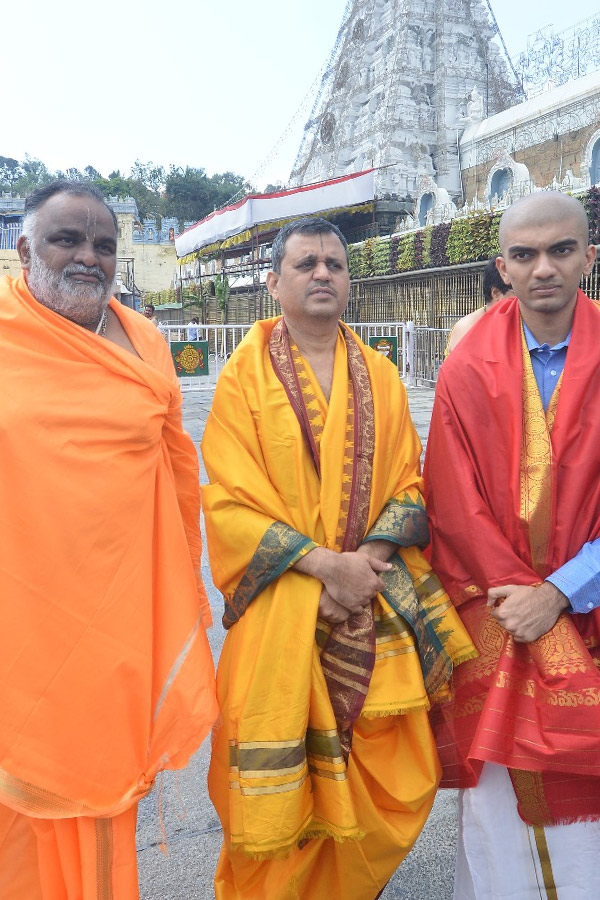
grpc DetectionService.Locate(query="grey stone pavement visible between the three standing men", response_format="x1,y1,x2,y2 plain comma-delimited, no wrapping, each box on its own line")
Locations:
137,387,456,900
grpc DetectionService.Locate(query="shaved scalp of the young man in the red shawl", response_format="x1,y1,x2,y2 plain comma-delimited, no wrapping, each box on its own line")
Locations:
498,191,589,255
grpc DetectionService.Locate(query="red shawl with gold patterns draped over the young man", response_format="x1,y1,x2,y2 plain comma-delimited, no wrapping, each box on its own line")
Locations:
425,292,600,824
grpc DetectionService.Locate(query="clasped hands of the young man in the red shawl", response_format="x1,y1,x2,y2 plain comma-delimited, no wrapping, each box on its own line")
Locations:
487,581,569,644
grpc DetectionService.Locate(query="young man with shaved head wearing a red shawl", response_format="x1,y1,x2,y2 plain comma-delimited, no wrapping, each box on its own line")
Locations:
426,192,600,900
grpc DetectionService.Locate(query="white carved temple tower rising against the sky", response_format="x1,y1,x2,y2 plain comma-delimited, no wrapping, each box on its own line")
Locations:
290,0,519,216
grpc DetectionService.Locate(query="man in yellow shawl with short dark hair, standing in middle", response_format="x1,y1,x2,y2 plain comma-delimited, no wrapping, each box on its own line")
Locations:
202,219,473,900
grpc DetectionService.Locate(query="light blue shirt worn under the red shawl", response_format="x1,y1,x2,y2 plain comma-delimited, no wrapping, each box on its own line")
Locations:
523,322,600,613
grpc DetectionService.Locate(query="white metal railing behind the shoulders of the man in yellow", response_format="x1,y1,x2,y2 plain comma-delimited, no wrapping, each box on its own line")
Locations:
160,322,449,391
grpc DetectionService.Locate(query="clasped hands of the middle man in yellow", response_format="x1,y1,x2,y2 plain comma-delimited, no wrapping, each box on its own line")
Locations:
296,545,392,625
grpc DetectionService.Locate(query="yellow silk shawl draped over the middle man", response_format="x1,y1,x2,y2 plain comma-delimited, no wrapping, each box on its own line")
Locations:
202,320,473,858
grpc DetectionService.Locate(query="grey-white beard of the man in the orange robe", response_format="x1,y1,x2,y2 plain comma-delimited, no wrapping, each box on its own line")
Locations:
27,246,114,330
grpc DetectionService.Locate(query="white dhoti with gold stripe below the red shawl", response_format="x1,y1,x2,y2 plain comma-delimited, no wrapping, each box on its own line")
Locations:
454,763,600,900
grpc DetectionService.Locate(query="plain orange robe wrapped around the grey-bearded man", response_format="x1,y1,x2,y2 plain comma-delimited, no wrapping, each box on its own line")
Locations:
0,277,217,900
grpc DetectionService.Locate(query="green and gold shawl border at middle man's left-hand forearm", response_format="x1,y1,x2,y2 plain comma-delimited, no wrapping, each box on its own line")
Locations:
223,522,318,628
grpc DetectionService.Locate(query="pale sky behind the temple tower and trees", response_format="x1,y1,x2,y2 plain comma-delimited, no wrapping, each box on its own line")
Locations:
0,0,600,186
